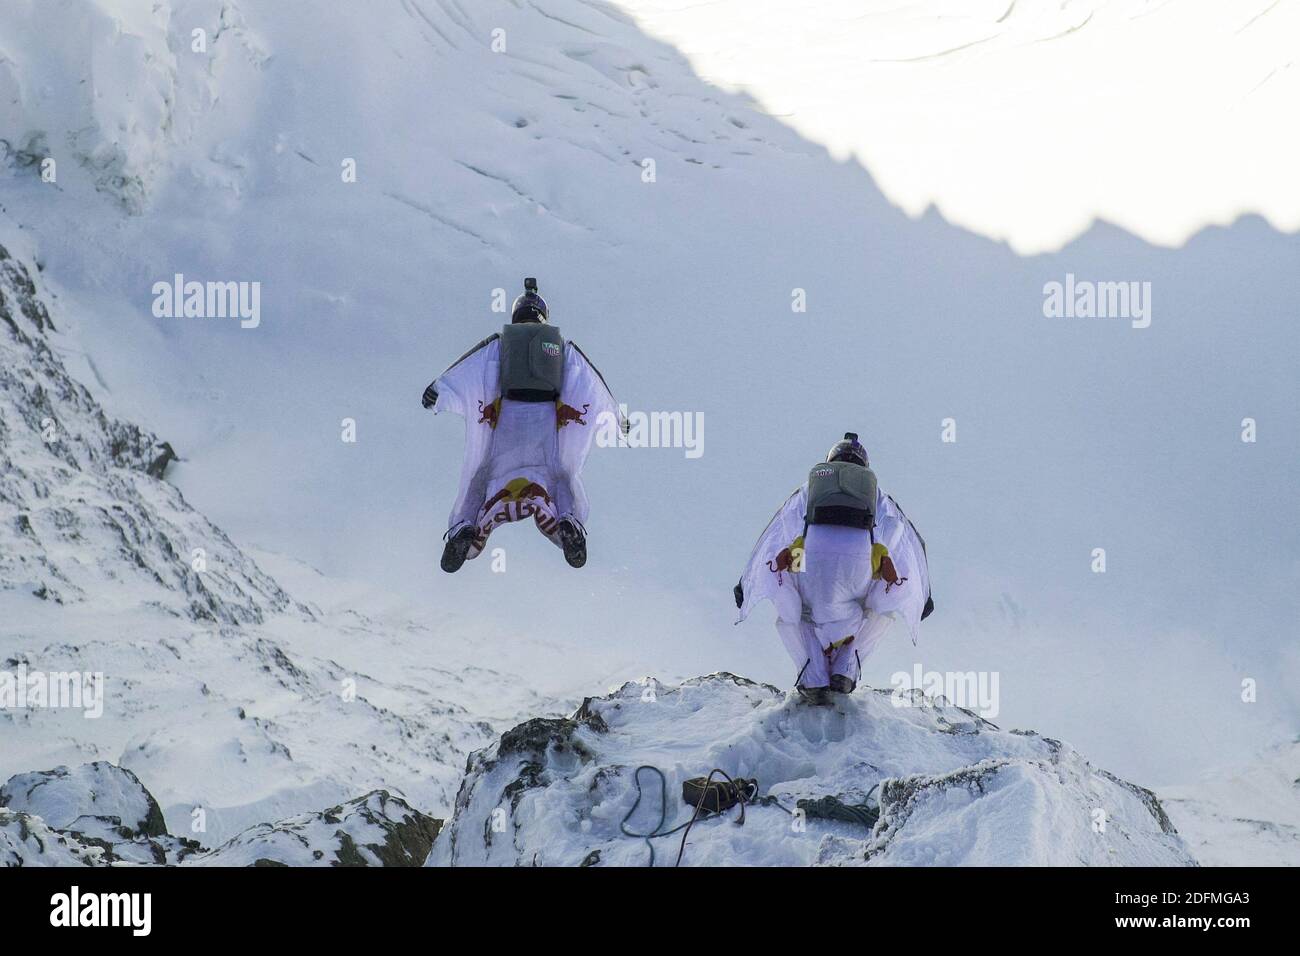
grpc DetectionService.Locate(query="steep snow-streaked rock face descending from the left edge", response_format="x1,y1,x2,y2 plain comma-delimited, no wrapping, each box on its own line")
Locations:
0,247,290,624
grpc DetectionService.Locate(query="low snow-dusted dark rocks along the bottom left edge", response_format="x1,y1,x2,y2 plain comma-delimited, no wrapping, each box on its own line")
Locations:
0,762,439,866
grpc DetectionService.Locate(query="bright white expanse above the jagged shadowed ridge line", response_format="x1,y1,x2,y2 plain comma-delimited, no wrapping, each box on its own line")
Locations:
616,0,1300,254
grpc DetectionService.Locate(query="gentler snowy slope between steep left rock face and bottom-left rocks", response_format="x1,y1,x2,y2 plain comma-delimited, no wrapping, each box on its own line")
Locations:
0,598,538,843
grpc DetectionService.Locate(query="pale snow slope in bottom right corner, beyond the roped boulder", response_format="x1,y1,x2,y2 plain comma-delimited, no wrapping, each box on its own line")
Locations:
1160,740,1300,866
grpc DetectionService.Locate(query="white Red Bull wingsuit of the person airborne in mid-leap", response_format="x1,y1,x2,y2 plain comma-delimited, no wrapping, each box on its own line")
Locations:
433,334,619,558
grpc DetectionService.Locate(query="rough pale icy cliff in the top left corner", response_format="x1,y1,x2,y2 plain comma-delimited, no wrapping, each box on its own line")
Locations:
0,0,268,213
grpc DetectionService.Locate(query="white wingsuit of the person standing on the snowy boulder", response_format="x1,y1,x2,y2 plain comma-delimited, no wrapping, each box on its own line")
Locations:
736,483,932,688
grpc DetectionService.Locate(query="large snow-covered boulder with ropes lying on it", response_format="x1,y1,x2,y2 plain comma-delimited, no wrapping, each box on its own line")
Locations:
429,674,1193,866
